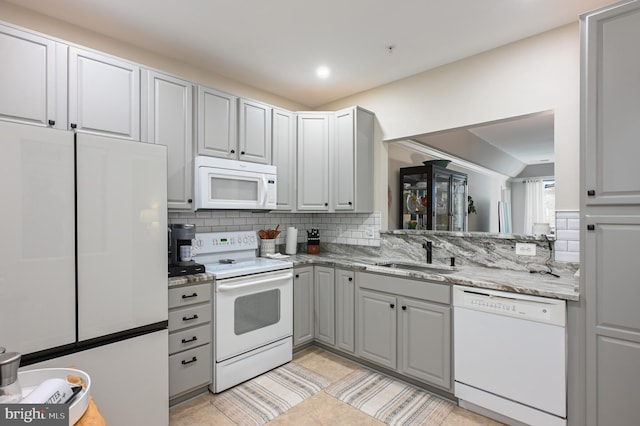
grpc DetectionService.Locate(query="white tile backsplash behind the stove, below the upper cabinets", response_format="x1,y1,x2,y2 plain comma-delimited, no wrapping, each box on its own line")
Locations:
169,210,380,247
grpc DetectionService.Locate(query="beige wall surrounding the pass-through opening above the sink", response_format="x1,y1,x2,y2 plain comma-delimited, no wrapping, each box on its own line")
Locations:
322,21,580,223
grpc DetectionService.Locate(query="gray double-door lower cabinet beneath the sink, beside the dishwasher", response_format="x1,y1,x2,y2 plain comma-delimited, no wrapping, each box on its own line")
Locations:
356,272,452,391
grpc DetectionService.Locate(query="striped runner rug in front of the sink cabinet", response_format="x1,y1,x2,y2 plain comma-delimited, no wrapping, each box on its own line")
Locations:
324,369,454,425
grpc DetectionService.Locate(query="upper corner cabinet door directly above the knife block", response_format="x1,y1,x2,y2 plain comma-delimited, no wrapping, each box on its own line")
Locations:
298,113,330,211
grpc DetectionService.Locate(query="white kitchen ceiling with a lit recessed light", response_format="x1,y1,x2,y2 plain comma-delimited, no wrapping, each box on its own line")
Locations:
5,0,612,108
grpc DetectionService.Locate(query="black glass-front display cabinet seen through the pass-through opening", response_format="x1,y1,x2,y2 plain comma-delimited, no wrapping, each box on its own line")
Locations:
398,165,467,232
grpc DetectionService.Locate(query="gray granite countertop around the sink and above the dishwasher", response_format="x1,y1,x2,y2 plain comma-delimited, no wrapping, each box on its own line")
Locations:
287,253,580,301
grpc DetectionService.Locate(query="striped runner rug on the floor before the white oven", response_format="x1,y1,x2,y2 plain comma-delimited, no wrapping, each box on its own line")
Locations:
211,363,329,426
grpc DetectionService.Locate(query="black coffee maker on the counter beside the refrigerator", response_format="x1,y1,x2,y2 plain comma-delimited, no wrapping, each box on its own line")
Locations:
168,223,204,277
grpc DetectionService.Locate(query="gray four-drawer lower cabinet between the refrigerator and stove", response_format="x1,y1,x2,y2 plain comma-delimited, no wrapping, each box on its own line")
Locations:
169,282,212,403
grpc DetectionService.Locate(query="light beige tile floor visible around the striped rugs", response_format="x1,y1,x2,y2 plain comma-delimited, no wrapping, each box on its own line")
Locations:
169,347,501,426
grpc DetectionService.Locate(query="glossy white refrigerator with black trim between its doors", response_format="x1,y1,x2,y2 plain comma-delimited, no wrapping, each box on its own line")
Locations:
0,122,168,425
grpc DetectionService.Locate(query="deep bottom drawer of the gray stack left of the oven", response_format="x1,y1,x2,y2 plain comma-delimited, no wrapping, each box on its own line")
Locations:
169,345,211,397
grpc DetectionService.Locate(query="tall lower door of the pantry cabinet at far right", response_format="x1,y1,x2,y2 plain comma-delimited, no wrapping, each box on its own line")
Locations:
581,215,640,425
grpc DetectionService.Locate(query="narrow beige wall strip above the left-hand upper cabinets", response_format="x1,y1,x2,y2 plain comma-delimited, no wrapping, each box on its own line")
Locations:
0,0,309,111
